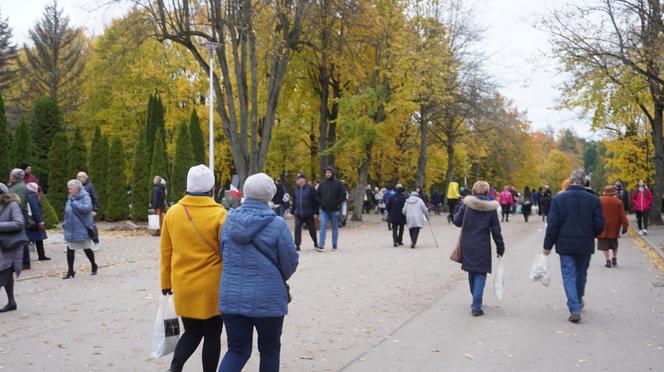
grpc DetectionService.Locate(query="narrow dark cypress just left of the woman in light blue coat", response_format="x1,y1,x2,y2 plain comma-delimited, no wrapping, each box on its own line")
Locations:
48,132,73,220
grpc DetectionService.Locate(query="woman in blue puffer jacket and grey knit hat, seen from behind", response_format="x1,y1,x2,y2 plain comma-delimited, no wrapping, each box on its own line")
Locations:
219,173,299,372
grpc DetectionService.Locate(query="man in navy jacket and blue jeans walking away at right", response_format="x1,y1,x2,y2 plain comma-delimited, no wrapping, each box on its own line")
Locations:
544,170,604,323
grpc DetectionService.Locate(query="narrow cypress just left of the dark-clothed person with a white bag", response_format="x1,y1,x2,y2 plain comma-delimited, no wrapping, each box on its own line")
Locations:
131,131,150,221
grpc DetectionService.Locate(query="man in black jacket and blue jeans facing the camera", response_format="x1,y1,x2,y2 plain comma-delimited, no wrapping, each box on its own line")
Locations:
316,166,346,252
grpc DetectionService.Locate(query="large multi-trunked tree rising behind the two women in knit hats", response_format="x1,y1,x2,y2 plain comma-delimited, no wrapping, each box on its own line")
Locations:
139,0,309,183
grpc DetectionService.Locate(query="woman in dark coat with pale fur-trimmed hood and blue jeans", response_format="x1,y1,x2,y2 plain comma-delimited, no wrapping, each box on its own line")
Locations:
454,181,505,316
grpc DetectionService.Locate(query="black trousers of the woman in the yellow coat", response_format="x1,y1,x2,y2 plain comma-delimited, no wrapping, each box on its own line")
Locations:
170,315,223,372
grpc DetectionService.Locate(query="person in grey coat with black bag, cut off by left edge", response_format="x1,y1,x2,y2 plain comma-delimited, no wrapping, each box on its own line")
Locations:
0,183,25,313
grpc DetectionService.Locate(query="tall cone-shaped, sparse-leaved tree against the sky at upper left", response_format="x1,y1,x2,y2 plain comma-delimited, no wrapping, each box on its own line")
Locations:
19,0,85,115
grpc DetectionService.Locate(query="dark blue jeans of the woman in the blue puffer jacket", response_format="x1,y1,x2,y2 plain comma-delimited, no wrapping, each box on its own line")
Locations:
219,314,284,372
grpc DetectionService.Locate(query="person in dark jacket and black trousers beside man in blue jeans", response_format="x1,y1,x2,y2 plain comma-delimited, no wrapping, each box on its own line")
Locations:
291,173,318,251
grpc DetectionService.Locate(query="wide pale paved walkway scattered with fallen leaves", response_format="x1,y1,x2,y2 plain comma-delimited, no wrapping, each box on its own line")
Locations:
0,216,664,372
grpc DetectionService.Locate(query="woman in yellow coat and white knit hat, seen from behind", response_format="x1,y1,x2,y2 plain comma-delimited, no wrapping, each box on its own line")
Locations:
161,165,226,372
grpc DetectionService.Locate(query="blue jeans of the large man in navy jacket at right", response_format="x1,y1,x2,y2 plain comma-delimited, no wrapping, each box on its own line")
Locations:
560,254,591,314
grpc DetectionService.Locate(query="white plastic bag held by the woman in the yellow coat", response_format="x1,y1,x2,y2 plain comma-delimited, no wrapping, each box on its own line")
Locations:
152,295,180,358
